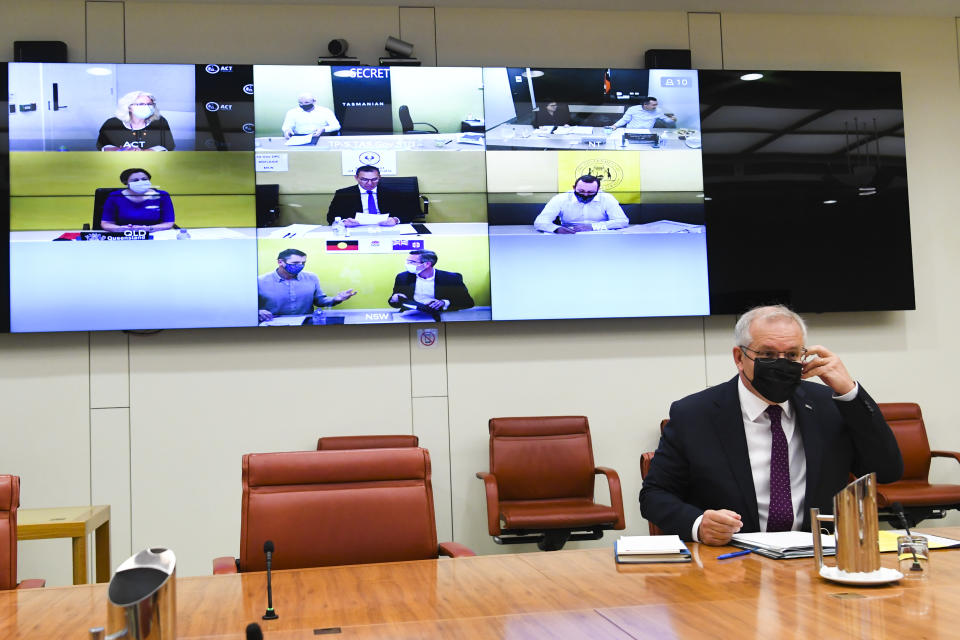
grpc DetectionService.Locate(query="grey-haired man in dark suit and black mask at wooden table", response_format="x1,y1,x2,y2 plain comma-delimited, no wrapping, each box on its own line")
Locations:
640,305,903,545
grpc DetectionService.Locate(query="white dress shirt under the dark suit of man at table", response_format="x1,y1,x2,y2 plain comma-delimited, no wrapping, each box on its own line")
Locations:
692,378,860,542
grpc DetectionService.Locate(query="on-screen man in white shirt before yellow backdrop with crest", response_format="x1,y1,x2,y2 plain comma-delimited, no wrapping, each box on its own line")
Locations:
533,175,630,233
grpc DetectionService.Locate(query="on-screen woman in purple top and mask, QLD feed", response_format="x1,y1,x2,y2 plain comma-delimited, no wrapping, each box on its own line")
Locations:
100,168,174,232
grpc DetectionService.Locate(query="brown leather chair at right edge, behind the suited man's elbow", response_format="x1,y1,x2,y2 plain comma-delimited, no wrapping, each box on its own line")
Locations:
877,402,960,527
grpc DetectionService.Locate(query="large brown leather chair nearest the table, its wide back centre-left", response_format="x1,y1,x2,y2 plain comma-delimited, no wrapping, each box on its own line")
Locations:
213,447,474,573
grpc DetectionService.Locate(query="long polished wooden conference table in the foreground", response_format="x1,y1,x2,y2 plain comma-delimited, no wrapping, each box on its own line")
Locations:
0,527,960,640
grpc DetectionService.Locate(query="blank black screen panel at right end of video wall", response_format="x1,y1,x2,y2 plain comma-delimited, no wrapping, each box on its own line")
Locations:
700,71,915,314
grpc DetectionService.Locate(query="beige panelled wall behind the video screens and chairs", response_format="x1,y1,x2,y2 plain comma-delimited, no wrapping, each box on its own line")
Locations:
0,1,960,584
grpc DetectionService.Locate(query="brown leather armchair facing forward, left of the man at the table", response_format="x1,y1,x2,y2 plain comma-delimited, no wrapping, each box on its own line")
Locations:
477,416,626,551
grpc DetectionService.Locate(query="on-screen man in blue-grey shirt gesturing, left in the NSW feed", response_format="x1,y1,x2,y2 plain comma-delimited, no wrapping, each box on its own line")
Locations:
257,249,357,322
